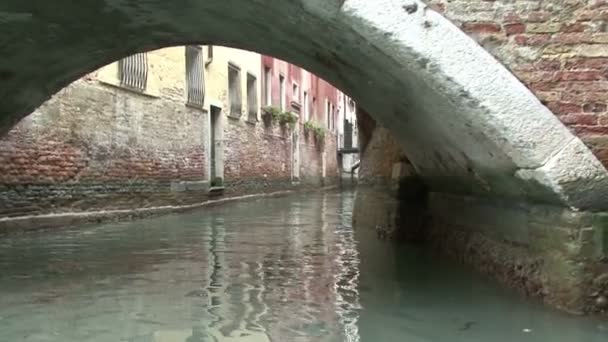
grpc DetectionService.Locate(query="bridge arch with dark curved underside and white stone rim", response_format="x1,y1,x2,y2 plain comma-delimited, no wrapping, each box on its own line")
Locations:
0,0,608,314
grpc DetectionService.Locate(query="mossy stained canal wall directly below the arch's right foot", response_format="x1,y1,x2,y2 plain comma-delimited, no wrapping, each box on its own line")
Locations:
428,193,608,313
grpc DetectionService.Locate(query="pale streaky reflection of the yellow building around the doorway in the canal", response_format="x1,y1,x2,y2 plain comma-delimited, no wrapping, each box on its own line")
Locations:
183,217,270,342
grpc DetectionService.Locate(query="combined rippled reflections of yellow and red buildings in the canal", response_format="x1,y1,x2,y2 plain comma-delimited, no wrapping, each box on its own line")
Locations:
147,195,359,342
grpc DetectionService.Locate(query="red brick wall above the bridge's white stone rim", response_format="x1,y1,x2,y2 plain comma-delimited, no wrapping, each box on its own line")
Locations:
429,0,608,165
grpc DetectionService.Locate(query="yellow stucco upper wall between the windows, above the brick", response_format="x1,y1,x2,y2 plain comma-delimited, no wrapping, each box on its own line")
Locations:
93,46,262,120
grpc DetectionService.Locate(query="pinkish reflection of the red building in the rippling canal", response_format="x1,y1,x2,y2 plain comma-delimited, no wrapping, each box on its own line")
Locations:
251,194,338,342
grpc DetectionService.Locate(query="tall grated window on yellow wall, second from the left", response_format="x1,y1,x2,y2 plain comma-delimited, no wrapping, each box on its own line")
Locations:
186,45,205,107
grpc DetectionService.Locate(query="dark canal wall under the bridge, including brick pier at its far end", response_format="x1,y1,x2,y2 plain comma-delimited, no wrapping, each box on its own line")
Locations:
353,112,608,313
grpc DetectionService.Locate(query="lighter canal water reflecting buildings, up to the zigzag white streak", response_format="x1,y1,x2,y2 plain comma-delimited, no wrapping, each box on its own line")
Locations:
0,194,359,342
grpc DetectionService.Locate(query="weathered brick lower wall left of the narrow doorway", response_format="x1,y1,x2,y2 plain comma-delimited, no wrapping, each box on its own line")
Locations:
0,80,207,216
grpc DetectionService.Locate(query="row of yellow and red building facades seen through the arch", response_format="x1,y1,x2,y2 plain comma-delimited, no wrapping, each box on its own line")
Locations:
0,46,356,225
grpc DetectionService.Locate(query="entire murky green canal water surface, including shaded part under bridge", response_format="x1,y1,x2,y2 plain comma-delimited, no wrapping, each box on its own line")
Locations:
0,192,608,342
